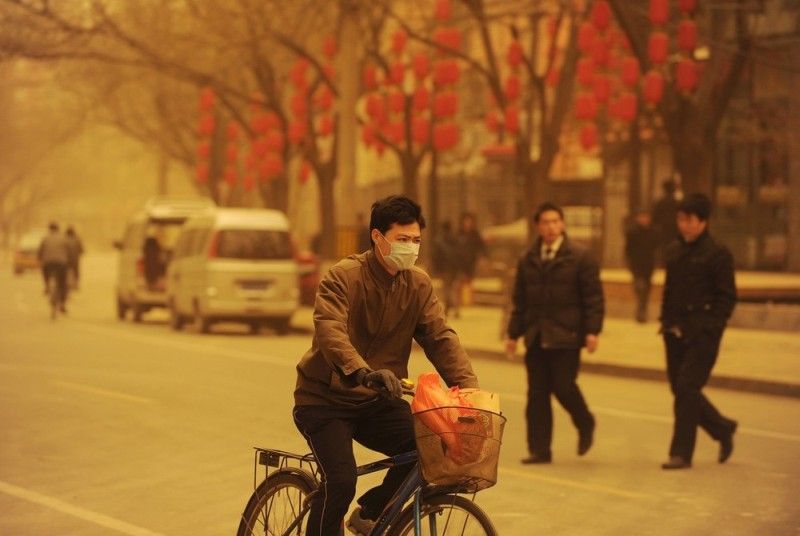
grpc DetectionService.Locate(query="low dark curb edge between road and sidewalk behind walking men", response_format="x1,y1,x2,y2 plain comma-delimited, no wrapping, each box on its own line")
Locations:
465,347,800,398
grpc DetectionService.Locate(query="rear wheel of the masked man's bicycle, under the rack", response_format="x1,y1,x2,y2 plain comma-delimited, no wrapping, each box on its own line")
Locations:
236,471,316,536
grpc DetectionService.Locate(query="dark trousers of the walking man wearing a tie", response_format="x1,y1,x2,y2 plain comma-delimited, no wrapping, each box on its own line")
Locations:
525,340,594,457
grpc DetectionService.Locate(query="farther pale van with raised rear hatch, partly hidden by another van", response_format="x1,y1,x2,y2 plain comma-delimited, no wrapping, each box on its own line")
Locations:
114,197,214,322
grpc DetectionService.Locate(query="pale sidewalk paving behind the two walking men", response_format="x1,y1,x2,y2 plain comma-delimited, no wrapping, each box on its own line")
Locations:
293,306,800,398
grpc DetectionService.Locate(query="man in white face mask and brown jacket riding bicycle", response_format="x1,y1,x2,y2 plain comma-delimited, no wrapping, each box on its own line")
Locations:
294,196,478,536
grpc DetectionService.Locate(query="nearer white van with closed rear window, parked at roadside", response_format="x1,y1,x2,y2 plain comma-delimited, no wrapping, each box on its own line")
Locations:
167,208,300,334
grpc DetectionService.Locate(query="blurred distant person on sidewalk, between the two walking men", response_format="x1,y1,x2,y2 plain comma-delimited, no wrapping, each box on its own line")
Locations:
625,209,658,323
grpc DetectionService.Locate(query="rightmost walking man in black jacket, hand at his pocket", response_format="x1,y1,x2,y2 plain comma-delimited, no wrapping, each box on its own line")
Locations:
661,194,737,469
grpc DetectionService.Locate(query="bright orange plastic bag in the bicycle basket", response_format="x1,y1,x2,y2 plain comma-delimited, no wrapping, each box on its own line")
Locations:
411,372,491,464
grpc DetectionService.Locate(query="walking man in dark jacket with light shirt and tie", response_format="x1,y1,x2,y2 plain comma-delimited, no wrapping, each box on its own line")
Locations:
506,203,604,464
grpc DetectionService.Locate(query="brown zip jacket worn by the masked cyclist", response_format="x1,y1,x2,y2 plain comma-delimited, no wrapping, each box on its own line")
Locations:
294,250,478,406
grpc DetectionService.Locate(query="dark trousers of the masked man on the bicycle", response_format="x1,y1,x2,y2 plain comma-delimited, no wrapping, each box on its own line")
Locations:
294,399,416,536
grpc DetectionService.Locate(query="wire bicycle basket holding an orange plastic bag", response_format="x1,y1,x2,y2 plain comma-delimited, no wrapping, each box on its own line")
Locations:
414,406,506,492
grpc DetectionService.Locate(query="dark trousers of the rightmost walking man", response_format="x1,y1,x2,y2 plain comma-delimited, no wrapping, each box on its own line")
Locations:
664,332,734,462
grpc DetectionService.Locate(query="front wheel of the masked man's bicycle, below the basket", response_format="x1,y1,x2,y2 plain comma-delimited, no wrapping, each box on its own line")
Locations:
390,495,497,536
